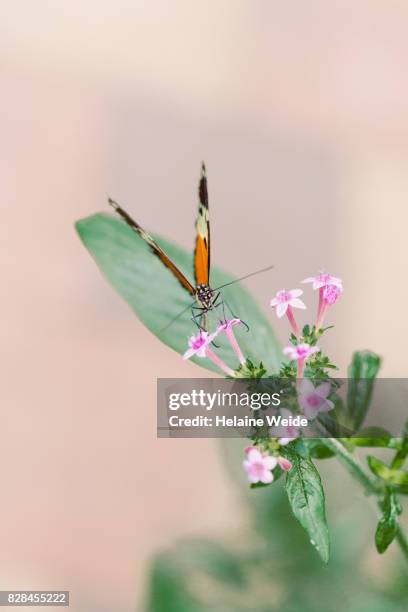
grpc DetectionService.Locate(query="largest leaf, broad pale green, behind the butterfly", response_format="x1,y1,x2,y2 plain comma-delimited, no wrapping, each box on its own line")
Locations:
76,213,281,372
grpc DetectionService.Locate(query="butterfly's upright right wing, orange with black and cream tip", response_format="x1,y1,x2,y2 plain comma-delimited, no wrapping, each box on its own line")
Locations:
194,163,210,286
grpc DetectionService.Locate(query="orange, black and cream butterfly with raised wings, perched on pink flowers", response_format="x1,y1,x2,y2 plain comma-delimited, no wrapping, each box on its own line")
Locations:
108,162,225,331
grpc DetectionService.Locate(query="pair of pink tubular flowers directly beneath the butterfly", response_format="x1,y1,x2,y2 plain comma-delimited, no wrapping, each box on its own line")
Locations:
183,319,246,376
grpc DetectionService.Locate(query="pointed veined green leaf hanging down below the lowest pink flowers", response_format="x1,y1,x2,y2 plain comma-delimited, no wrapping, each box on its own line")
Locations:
286,453,330,563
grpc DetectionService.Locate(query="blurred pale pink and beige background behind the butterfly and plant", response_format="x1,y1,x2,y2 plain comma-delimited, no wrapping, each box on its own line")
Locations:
0,0,408,612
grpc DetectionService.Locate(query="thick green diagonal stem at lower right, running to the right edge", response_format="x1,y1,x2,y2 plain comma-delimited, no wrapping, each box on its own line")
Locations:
321,438,408,562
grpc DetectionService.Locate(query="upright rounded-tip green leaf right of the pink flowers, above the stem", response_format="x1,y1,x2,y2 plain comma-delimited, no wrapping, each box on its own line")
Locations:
347,351,381,429
